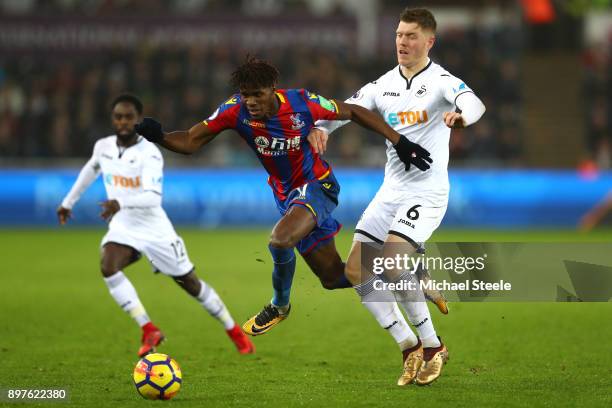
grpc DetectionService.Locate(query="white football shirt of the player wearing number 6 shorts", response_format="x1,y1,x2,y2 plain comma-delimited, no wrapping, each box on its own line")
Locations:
316,60,480,205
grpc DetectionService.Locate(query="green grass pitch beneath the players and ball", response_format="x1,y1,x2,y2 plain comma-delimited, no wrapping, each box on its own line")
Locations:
0,228,612,407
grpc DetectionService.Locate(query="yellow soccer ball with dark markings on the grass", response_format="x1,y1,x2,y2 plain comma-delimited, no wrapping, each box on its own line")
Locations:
133,353,183,400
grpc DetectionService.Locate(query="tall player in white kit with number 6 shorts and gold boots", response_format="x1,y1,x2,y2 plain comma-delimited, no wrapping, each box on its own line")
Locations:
309,8,485,385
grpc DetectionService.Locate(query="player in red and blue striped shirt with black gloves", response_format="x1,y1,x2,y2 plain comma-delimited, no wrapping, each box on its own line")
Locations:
137,57,431,336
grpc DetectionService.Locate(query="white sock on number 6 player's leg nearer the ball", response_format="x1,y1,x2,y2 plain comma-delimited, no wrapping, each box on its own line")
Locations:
354,277,418,351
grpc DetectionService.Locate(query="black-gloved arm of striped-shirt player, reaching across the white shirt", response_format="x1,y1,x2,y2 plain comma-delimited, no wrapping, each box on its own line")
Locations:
335,101,433,171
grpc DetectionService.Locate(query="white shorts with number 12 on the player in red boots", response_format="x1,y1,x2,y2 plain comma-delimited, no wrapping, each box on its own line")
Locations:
100,229,193,276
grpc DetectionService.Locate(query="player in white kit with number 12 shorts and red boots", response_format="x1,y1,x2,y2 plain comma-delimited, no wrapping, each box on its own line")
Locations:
57,94,254,356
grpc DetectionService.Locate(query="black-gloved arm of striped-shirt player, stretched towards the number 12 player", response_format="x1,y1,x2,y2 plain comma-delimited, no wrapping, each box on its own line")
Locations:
136,118,217,154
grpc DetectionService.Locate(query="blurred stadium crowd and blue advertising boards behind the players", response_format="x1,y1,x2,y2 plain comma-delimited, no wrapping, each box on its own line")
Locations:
0,0,612,227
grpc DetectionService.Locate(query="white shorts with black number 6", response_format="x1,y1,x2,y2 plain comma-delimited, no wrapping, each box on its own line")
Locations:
353,189,447,248
